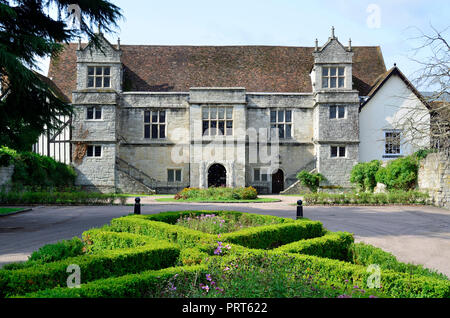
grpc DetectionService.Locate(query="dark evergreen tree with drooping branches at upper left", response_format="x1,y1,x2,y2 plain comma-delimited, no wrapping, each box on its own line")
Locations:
0,0,122,150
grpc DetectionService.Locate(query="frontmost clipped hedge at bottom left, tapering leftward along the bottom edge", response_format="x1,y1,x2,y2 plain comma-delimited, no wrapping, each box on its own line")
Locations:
19,265,206,298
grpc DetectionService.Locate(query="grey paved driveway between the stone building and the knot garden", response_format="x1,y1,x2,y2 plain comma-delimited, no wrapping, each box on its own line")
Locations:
0,197,450,276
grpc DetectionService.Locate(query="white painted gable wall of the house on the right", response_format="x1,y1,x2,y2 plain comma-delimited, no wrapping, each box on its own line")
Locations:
359,74,430,162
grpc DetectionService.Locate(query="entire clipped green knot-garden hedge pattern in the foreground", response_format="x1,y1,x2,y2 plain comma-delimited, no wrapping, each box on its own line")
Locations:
0,211,450,298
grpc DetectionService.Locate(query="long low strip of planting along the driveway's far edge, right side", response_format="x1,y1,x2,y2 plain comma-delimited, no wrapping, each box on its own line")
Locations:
303,191,429,205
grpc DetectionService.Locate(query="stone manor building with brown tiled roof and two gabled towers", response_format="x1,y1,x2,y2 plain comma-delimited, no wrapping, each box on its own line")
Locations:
49,30,386,193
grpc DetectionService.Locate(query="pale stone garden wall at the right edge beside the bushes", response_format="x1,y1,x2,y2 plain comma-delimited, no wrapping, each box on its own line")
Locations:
418,154,450,209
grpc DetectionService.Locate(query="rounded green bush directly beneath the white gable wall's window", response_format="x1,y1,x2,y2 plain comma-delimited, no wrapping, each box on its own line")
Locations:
376,156,419,191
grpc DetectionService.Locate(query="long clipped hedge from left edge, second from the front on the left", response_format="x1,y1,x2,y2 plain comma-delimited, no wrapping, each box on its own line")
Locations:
0,241,180,297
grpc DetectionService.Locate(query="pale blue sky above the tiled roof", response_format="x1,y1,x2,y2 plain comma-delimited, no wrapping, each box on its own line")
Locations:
37,0,450,89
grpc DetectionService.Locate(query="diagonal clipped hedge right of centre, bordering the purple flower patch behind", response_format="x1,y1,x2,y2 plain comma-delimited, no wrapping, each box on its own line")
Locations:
221,220,324,249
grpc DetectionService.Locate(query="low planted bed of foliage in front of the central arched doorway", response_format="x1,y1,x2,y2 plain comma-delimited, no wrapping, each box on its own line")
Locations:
175,187,258,201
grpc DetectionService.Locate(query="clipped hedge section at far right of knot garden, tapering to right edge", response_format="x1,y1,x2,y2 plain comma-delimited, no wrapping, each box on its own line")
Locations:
349,243,448,280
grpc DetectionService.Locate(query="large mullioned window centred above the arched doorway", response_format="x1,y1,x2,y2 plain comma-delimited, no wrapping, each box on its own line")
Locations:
201,106,234,137
